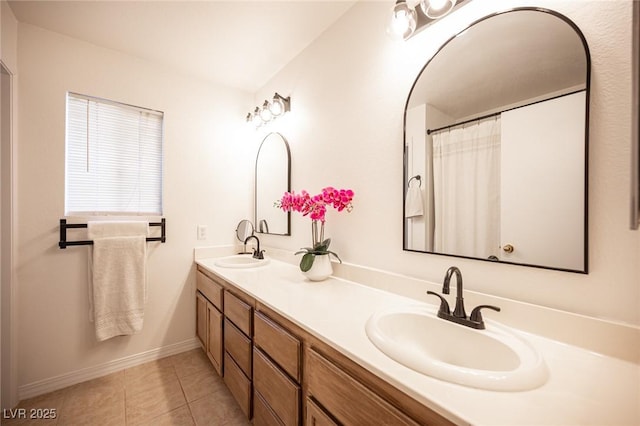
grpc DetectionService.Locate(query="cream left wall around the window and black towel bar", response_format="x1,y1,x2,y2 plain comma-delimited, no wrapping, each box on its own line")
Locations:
17,23,257,392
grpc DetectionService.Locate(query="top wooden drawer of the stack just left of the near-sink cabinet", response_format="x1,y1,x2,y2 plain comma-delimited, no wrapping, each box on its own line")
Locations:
253,312,302,383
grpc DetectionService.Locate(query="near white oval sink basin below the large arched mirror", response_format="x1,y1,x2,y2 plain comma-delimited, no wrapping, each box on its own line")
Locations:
366,306,548,391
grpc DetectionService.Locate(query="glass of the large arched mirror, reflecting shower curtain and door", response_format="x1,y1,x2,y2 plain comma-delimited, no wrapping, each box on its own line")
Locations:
403,8,590,273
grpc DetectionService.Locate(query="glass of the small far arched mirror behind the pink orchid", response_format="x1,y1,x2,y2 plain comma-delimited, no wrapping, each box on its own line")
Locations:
255,132,291,235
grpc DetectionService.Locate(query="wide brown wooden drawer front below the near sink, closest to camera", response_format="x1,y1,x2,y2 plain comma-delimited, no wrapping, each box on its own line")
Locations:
305,349,417,426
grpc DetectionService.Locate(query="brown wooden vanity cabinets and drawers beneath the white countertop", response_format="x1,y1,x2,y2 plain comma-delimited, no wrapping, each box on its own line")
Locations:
196,261,452,425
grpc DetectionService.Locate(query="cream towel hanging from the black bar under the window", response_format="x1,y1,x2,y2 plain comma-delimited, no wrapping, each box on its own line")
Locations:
88,221,149,341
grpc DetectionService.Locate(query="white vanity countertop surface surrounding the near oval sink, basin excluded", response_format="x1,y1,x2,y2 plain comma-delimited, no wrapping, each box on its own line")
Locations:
196,258,640,426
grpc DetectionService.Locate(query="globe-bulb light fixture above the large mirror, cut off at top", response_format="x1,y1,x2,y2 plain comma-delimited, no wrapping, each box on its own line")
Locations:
388,0,471,40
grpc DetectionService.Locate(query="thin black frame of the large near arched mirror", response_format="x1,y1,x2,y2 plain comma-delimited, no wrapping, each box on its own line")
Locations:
402,7,591,274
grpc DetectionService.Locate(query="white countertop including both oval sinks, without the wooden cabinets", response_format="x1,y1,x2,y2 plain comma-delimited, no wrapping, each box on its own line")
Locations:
196,250,640,425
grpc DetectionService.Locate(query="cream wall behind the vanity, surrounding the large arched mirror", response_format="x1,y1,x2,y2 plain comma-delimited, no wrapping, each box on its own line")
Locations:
256,0,640,326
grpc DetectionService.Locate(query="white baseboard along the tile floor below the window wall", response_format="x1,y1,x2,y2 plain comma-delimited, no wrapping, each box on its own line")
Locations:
18,337,200,401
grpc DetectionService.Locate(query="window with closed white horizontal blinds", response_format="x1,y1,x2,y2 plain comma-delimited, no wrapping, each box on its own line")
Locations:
65,93,163,215
